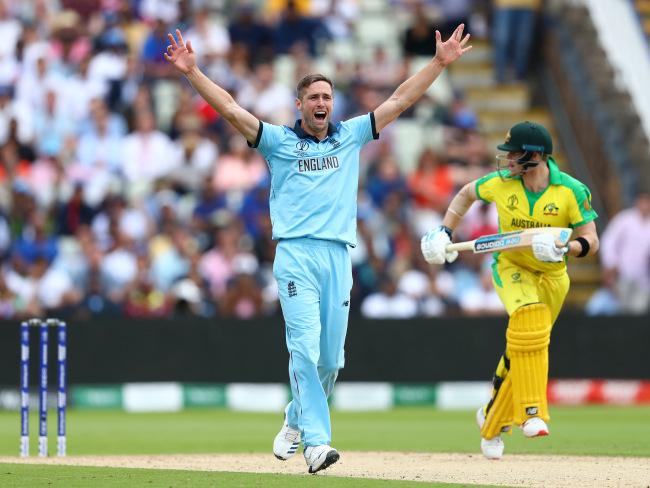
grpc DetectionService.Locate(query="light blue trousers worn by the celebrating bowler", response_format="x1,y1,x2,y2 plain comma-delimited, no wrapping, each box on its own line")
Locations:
273,238,352,447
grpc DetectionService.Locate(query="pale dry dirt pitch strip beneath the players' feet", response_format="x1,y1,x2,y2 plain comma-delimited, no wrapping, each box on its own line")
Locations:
0,451,650,488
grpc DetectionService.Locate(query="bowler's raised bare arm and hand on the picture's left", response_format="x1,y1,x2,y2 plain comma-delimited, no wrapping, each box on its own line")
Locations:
165,29,260,143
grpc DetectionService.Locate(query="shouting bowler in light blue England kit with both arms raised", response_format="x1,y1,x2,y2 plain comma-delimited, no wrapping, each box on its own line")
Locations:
165,24,471,473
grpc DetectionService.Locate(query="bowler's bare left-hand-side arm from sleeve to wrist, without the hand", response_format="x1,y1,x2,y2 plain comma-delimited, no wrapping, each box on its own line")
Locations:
186,67,260,144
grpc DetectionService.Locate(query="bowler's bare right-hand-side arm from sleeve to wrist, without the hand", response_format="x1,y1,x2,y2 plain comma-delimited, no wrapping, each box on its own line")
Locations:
375,57,444,132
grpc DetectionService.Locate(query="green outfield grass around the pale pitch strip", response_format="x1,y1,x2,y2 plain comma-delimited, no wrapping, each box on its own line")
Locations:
0,407,650,487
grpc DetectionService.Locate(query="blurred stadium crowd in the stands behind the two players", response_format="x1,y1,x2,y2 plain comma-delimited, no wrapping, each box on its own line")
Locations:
0,0,644,318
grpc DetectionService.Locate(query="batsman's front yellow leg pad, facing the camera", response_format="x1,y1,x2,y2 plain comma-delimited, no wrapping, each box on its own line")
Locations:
506,303,552,425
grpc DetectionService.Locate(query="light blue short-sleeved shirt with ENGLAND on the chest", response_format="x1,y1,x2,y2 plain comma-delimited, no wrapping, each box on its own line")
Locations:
251,112,379,247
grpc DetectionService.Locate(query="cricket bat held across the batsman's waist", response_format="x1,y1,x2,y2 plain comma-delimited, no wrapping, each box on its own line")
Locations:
446,227,573,254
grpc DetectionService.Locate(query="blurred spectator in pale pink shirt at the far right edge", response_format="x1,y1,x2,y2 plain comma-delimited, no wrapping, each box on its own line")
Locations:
600,191,650,314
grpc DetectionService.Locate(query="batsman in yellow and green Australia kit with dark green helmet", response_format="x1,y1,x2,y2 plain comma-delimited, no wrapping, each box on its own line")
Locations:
421,121,598,459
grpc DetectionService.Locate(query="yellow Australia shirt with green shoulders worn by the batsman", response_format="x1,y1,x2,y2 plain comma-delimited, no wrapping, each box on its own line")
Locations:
476,158,598,272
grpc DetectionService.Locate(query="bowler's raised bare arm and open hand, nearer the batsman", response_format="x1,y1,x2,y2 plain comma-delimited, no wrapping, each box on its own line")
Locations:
375,24,472,132
